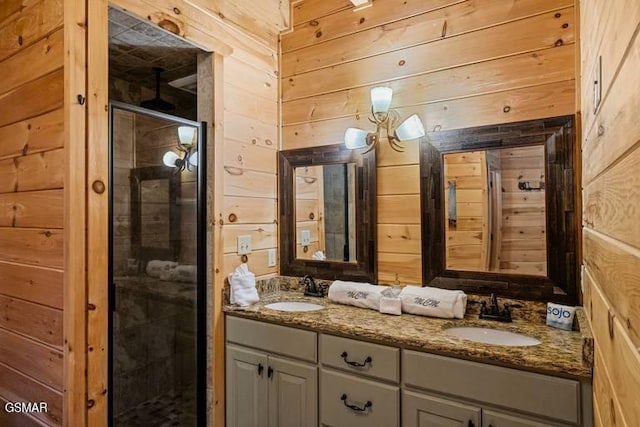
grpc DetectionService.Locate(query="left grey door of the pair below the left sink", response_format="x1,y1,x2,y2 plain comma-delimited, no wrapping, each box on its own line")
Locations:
226,345,268,427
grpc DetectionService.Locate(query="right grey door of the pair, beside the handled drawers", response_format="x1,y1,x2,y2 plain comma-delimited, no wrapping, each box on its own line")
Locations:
267,356,318,427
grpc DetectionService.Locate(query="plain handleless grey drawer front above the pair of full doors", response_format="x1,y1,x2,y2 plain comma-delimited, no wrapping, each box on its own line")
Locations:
226,316,318,362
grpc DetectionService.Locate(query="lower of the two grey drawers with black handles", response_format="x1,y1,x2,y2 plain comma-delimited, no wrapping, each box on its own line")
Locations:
320,369,400,427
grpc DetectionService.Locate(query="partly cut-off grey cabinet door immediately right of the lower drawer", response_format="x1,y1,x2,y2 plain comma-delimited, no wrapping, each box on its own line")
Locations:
402,391,481,427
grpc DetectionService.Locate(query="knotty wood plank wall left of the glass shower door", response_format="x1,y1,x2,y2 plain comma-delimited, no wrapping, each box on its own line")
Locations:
0,0,65,425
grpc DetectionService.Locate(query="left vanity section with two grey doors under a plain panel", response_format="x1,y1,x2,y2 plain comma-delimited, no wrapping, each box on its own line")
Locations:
226,317,318,427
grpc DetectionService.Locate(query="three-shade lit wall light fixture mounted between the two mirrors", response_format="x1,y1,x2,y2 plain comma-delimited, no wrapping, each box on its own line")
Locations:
344,86,425,153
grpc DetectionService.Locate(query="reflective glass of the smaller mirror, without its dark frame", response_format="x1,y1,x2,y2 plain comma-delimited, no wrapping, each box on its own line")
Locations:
295,163,356,262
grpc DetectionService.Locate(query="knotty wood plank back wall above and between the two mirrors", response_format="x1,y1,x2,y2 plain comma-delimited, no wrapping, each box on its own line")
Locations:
280,0,576,283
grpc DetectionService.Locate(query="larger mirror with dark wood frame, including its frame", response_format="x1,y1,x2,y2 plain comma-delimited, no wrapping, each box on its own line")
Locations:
420,116,578,304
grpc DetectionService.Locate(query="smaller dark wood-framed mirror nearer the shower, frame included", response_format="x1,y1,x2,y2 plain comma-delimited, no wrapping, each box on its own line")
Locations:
278,144,376,283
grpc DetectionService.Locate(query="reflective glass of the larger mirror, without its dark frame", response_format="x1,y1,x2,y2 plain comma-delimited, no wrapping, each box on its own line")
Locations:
444,145,547,276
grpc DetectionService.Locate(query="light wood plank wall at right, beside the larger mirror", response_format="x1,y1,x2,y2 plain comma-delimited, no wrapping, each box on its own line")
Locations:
581,0,640,427
